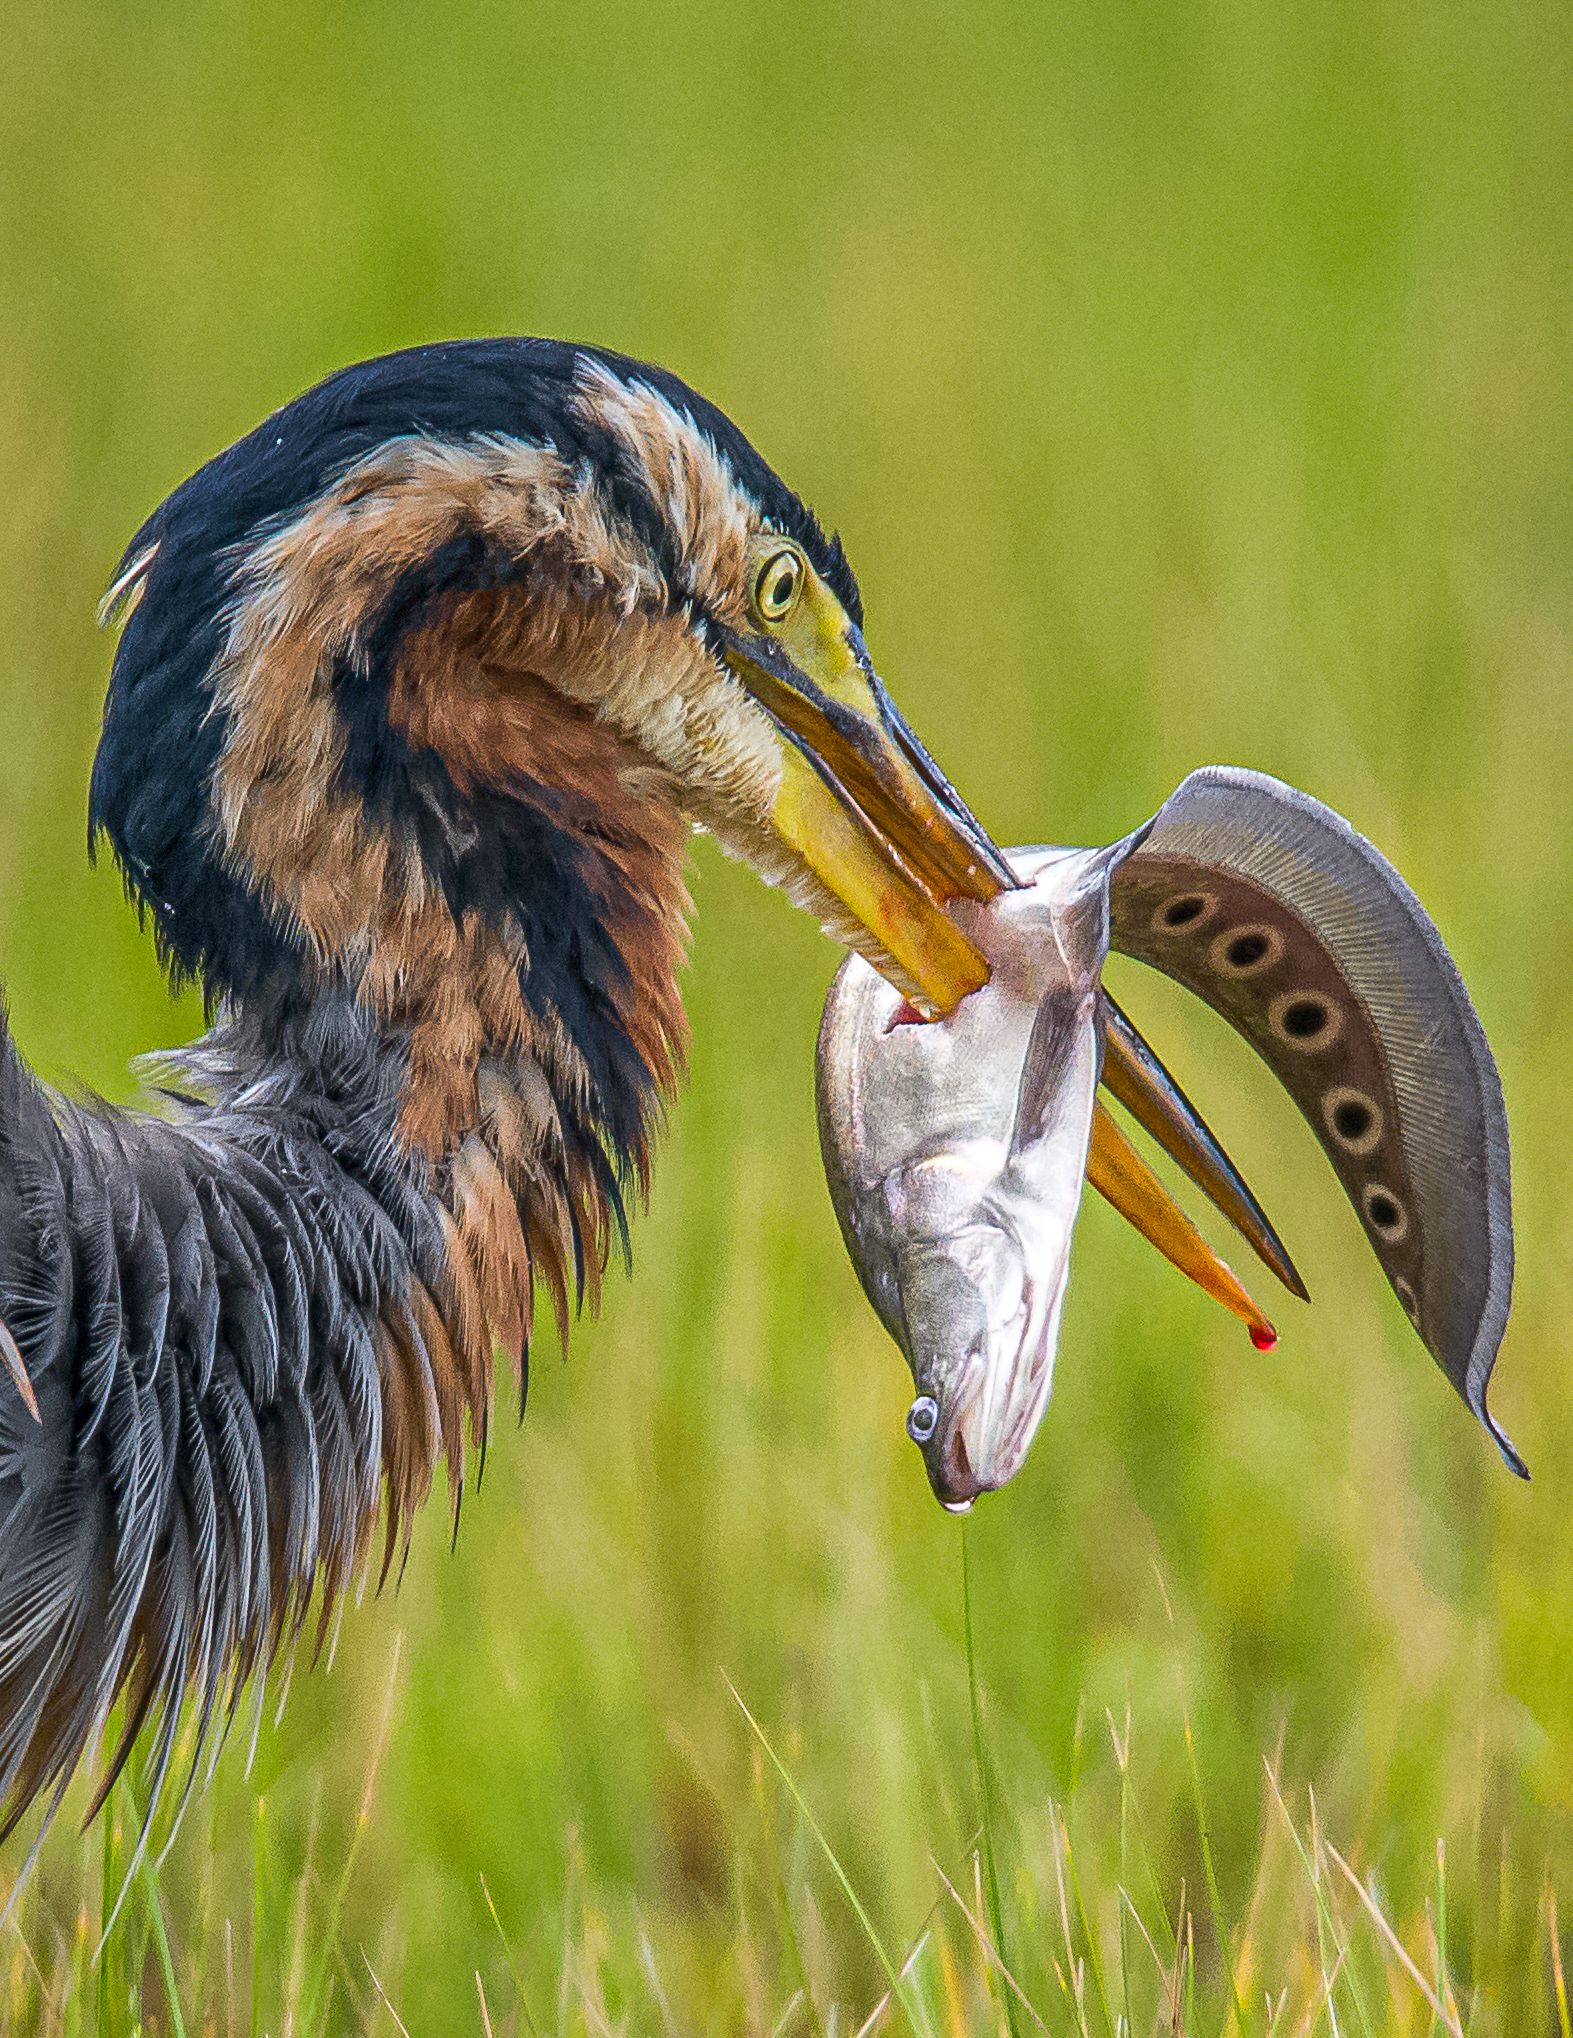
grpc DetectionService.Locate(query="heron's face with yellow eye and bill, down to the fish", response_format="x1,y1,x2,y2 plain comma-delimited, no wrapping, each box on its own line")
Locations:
533,355,1013,1011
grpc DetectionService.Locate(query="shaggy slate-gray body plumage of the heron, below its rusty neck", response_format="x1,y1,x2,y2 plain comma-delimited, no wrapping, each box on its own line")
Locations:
0,1015,464,1834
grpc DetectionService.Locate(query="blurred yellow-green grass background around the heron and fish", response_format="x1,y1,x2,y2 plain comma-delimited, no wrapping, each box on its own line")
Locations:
0,0,1573,2038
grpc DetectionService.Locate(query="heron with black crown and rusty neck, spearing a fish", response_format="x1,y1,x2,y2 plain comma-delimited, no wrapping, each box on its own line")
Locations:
0,338,1255,1832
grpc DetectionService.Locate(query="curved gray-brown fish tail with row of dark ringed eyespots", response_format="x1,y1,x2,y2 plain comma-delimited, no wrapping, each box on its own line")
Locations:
1110,766,1528,1476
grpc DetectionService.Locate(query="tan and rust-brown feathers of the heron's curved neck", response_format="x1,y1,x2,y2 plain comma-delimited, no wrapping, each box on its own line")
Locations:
202,446,713,1418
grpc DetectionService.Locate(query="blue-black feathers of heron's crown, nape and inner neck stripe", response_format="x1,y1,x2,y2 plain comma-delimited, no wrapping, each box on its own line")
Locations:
90,340,862,1027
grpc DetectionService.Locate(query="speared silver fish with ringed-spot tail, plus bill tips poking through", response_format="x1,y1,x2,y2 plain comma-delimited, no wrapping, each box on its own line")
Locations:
815,766,1528,1512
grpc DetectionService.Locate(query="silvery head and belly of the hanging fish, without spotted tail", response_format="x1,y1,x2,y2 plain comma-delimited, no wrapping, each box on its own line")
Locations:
817,846,1123,1510
